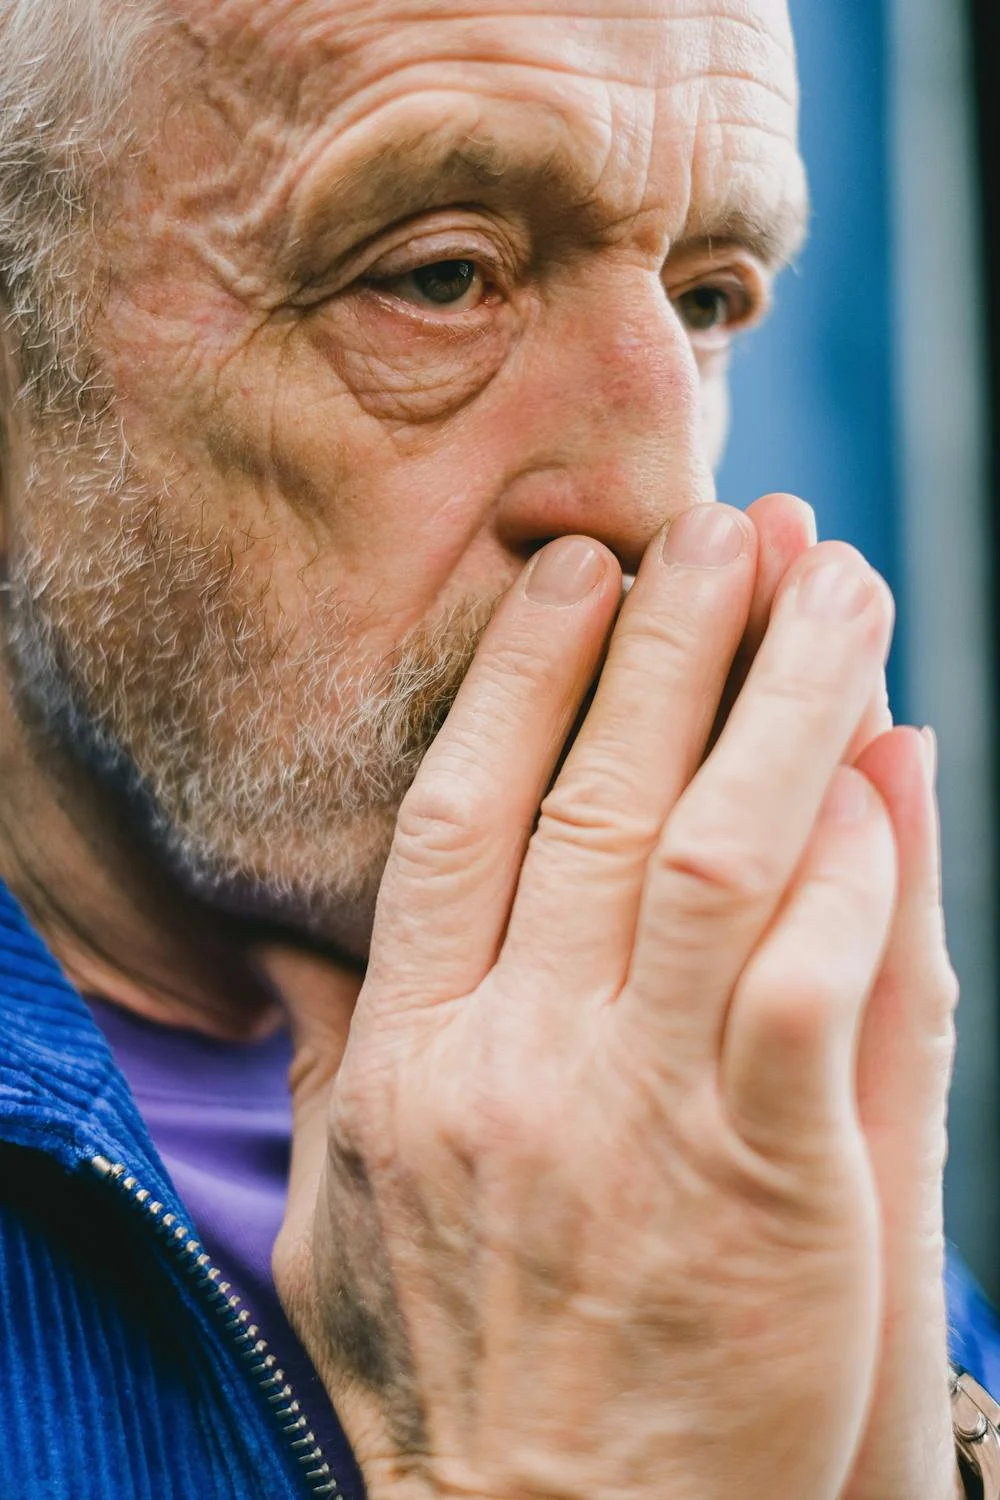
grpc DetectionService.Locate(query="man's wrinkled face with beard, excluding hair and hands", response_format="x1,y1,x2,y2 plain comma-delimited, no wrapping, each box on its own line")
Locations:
3,0,804,932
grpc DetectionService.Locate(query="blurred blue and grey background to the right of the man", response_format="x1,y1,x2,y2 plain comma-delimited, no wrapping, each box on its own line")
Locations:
720,0,1000,1301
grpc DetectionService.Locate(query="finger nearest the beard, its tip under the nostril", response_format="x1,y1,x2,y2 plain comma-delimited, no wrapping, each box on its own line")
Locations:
363,537,621,1004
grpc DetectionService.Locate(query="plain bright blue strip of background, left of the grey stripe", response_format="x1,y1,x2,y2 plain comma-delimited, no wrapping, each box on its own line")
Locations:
720,0,906,690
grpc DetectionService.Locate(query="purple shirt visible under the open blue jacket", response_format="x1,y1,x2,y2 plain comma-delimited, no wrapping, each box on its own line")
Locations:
87,996,364,1497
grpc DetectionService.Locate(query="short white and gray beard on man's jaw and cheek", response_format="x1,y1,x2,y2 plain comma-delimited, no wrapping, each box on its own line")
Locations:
7,414,495,936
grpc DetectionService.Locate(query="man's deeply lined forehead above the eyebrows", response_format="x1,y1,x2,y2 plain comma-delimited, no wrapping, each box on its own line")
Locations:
162,0,805,264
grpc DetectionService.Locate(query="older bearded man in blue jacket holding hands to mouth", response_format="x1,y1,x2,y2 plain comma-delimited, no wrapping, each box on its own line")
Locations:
0,0,997,1500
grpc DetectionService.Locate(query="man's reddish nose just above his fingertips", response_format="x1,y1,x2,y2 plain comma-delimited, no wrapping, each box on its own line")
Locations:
496,272,715,573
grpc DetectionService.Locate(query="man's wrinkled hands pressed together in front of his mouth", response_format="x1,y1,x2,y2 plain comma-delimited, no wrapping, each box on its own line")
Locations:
276,495,958,1500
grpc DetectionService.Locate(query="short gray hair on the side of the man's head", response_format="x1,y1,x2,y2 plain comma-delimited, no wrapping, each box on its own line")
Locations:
0,0,157,419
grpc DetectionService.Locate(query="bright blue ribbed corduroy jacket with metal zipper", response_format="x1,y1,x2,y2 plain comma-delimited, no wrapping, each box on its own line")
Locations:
0,885,1000,1500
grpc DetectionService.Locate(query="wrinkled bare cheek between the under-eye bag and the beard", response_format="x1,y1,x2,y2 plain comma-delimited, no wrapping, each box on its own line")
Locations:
121,324,517,627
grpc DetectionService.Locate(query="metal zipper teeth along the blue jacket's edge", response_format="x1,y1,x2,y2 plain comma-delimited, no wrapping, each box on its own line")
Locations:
90,1155,343,1500
